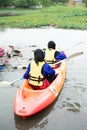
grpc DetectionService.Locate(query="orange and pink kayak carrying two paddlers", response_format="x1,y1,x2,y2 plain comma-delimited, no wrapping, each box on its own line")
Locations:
14,61,66,118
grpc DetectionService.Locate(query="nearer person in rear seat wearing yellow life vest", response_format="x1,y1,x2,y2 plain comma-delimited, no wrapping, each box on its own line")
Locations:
23,49,55,90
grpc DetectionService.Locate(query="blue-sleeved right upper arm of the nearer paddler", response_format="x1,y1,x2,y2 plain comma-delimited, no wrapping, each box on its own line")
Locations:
42,63,55,76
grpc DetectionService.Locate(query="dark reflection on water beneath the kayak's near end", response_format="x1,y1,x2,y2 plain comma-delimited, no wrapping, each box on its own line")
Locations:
14,102,55,130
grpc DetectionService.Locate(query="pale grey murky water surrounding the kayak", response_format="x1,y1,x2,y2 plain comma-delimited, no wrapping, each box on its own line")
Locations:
0,28,87,130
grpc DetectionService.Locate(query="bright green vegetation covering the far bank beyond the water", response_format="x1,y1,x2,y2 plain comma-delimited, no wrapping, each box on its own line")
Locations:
0,4,87,30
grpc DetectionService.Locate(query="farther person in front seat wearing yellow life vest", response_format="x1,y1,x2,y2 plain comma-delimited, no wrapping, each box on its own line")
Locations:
45,41,66,68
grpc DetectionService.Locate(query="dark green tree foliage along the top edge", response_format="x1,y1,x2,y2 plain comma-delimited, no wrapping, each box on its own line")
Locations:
0,0,67,7
